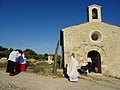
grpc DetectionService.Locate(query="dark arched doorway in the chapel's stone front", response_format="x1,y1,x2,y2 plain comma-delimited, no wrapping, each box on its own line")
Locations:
88,50,101,73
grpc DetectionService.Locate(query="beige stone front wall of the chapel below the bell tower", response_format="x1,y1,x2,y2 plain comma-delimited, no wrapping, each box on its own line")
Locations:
62,22,120,77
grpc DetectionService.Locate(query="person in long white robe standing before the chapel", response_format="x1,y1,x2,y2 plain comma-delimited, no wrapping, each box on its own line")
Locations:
67,53,79,82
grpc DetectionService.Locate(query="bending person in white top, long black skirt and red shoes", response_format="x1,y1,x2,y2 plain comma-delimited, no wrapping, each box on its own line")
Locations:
6,50,19,76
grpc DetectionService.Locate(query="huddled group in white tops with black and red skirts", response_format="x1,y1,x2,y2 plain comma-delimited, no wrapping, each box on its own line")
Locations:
6,50,27,76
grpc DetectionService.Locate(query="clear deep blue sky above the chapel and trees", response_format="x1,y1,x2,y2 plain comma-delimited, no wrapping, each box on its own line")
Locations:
0,0,120,54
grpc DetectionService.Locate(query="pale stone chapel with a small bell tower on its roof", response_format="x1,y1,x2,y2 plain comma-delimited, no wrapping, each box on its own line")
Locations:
60,4,120,77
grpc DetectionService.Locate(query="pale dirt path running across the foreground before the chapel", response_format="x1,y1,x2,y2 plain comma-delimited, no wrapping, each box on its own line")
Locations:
0,70,120,90
